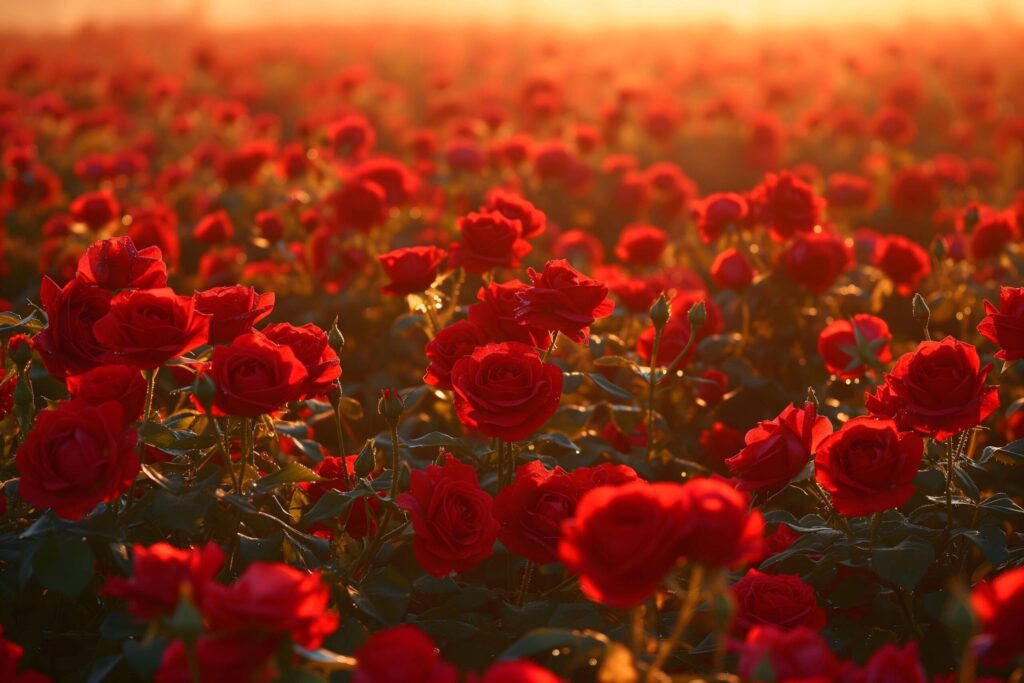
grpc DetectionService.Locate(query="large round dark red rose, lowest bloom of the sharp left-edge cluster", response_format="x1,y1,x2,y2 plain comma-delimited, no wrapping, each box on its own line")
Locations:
16,400,139,519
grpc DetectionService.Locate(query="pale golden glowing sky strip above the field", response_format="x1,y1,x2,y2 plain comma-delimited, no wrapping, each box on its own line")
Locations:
0,0,1024,31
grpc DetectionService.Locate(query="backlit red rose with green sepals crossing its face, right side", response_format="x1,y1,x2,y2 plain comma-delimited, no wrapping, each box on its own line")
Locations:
818,313,893,379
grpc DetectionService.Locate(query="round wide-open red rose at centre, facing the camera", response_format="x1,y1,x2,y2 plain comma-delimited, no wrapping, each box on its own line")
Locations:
451,342,562,441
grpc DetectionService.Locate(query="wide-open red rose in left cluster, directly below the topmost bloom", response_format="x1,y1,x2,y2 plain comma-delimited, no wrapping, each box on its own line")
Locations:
94,288,210,370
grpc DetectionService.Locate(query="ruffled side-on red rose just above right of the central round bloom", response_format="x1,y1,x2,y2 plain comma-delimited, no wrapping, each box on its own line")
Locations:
516,260,615,344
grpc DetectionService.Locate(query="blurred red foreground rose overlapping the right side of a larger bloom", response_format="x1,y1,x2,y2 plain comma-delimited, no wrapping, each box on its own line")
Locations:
682,478,765,567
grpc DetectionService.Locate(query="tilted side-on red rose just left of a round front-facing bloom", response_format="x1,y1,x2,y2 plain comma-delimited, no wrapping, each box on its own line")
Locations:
725,402,833,490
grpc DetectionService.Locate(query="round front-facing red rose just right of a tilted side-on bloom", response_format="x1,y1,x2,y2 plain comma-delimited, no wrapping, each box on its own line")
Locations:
814,417,925,516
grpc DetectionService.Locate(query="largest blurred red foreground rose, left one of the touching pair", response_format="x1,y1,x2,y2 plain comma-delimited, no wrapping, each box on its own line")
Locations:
558,481,698,607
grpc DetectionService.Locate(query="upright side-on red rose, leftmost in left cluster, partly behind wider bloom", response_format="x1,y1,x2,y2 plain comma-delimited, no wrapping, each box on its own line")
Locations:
32,278,111,380
